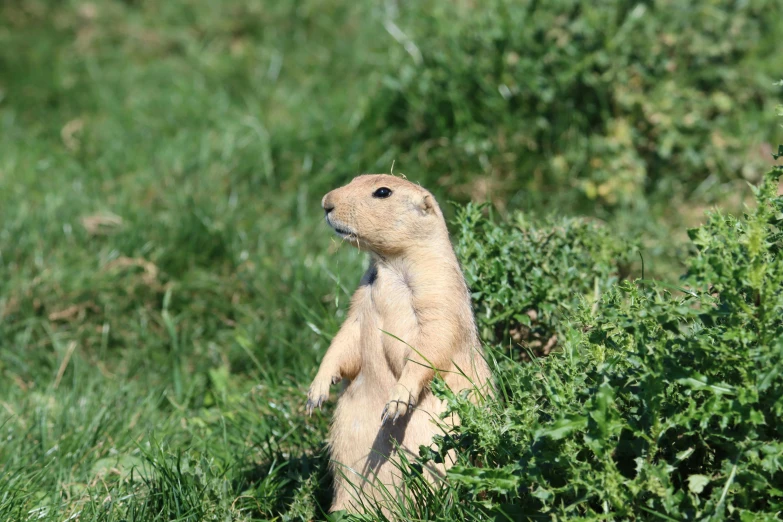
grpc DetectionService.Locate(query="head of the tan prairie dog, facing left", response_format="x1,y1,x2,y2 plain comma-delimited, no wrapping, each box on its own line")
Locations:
321,174,448,256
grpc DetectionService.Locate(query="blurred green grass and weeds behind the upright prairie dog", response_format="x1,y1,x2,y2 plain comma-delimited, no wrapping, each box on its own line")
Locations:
0,0,783,520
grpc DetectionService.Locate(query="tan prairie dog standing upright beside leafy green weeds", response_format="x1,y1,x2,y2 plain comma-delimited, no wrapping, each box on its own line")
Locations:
306,174,491,512
